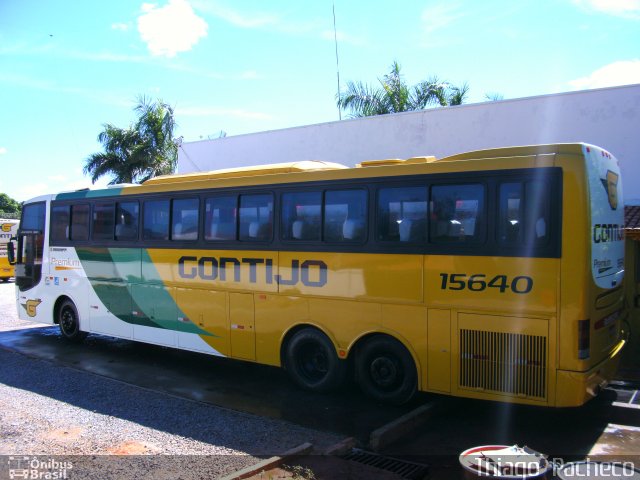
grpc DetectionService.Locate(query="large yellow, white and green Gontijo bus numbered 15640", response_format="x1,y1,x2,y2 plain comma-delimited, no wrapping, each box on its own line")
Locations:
11,144,627,407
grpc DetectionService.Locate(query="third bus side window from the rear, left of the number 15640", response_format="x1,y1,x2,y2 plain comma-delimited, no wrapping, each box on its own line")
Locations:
377,187,427,243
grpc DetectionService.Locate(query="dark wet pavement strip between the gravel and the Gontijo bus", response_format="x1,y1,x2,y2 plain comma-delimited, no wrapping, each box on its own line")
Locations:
0,326,425,442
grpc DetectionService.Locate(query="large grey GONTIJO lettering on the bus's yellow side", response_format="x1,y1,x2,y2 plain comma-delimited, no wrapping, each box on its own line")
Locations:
178,255,327,287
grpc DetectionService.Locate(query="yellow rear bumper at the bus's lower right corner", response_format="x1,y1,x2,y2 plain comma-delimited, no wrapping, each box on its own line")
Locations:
555,340,626,407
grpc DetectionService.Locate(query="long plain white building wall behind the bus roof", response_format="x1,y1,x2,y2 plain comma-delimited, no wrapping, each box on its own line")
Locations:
178,84,640,205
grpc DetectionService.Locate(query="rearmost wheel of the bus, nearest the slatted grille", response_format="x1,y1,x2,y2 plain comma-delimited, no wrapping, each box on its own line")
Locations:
355,335,418,405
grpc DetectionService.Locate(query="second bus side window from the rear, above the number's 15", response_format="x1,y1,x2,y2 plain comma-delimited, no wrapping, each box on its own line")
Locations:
430,184,485,243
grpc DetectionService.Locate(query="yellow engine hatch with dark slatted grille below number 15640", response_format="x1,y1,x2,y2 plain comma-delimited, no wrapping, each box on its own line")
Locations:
460,330,547,399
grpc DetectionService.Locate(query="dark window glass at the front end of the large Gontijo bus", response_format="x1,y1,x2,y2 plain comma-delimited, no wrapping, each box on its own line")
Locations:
9,202,45,292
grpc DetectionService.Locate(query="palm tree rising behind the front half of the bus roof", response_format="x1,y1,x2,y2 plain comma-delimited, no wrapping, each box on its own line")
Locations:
83,97,178,184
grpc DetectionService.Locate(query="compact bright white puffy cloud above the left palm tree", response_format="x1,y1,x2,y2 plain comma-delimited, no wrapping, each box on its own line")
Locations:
138,0,208,58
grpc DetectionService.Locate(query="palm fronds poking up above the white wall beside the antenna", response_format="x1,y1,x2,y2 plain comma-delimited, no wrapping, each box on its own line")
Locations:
337,62,469,117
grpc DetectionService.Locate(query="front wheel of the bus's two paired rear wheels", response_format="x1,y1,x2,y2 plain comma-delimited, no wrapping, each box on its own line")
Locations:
284,328,347,392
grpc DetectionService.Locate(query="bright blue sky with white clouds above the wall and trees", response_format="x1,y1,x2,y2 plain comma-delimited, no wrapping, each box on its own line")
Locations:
0,0,640,201
